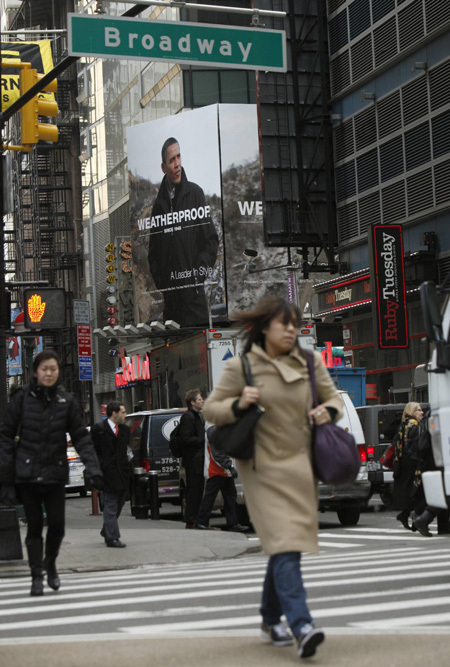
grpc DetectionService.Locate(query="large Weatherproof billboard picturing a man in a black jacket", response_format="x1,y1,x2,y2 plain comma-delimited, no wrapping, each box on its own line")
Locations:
127,104,298,327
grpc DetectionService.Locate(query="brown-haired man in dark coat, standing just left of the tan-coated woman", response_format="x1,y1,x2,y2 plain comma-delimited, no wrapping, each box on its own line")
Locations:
180,389,205,528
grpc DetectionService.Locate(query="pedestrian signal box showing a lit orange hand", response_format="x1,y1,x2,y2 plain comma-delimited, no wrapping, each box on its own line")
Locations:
23,287,66,329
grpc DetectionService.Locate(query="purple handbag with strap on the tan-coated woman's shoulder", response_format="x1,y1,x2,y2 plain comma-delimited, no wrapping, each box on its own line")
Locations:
306,352,361,486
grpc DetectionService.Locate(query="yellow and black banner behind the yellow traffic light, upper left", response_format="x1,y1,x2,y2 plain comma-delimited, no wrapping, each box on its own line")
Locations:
0,39,55,111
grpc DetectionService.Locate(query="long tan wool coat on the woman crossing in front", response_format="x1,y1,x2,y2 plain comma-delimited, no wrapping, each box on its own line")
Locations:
202,345,342,556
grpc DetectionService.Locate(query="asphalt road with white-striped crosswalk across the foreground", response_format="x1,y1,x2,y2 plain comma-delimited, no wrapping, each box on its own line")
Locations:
0,497,450,667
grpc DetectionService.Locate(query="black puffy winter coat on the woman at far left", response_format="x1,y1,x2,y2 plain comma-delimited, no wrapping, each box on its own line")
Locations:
0,380,101,485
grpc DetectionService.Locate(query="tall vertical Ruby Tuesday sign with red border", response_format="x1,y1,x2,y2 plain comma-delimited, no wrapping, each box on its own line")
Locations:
372,225,408,349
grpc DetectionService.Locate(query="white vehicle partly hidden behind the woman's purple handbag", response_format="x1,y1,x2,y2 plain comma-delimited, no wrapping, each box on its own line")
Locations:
319,391,371,526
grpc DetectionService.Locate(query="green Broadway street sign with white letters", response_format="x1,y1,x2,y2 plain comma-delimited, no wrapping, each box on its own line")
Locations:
68,14,286,72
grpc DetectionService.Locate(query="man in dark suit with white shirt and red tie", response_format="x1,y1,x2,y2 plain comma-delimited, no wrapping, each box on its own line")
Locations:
91,401,130,548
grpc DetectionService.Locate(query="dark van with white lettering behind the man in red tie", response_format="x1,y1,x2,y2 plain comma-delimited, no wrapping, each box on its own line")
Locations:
125,408,187,516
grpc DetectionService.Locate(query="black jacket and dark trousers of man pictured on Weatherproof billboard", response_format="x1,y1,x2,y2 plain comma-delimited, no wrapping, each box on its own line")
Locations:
148,169,219,327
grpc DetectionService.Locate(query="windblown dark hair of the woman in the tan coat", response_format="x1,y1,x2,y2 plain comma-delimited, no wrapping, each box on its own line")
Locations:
232,296,301,352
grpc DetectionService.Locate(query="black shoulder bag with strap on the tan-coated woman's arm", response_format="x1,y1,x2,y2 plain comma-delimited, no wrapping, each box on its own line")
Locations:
208,354,264,459
